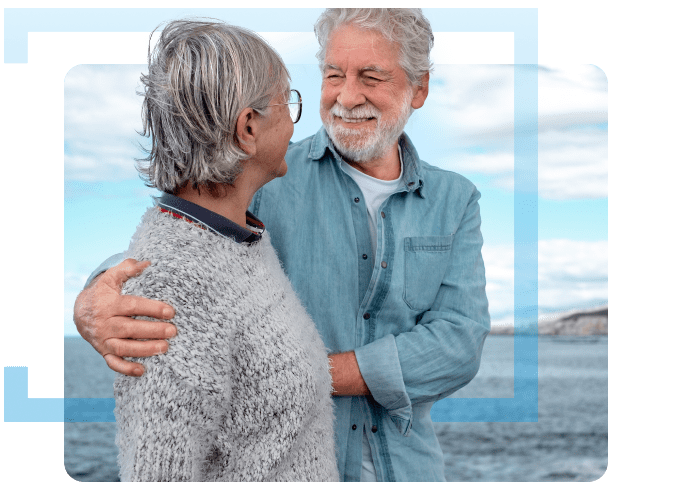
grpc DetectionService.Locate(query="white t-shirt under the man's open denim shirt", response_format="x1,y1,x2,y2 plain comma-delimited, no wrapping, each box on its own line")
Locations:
341,149,404,482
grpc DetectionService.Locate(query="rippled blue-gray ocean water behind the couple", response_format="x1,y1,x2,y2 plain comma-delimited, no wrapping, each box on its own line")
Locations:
64,336,608,482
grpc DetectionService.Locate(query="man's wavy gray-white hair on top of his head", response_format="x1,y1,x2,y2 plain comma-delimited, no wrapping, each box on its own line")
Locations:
314,8,435,85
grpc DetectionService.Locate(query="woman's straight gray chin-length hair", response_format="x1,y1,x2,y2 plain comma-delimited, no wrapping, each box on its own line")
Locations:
137,19,290,195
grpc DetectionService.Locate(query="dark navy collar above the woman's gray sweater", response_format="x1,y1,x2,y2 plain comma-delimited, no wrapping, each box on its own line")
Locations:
155,193,264,243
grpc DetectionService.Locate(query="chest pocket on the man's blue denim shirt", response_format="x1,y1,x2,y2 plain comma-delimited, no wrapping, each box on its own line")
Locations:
404,234,454,311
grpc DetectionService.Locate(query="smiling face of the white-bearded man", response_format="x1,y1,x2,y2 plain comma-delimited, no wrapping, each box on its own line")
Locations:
321,25,427,162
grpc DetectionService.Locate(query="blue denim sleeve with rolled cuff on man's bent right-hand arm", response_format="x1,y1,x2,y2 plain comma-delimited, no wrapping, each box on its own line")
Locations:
354,189,490,435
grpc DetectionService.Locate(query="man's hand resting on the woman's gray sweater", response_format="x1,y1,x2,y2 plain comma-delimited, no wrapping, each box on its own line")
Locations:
74,259,176,376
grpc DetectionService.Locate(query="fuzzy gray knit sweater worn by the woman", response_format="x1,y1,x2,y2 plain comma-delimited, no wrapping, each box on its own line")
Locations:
114,208,338,482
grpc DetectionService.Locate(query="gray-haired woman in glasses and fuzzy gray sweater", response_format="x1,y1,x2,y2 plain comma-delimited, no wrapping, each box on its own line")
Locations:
114,20,338,482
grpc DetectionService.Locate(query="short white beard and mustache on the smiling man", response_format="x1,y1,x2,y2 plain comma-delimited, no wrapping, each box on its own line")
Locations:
323,89,413,163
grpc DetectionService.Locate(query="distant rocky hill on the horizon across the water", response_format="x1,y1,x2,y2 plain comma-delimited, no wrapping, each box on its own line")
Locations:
491,306,608,336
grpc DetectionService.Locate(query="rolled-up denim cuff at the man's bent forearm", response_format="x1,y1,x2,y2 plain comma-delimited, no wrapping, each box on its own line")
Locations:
354,335,413,437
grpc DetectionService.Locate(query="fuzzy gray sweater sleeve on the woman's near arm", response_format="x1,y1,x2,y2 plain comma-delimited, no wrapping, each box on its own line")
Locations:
114,218,235,482
